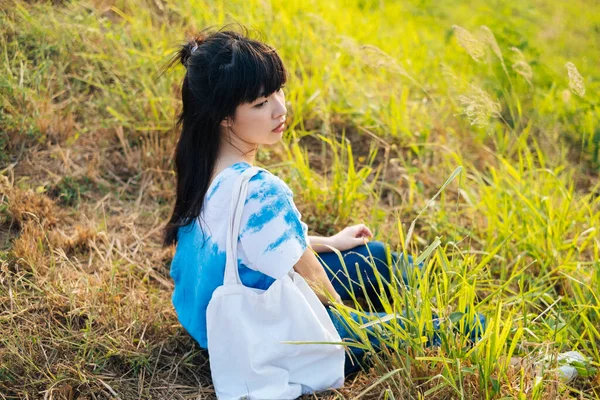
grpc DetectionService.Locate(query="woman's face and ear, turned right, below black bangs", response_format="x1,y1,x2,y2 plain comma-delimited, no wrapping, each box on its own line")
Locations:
221,88,287,147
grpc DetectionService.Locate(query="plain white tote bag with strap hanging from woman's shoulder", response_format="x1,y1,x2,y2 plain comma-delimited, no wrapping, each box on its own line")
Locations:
206,167,345,399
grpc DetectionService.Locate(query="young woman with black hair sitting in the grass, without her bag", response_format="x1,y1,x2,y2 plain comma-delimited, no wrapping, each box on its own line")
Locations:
164,24,426,384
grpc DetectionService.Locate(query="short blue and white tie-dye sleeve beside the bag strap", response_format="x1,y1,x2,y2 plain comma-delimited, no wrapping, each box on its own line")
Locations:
238,171,308,279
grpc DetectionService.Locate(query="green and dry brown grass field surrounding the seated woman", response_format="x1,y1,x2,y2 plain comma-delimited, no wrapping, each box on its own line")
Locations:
0,0,600,399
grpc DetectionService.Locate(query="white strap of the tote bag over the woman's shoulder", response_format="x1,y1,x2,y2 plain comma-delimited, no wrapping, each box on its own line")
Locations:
223,167,264,285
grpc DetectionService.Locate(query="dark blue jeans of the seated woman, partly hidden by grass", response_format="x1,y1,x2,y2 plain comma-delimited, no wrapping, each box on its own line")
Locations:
318,241,485,376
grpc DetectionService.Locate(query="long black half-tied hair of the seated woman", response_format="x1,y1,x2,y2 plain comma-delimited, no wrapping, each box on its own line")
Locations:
163,24,287,246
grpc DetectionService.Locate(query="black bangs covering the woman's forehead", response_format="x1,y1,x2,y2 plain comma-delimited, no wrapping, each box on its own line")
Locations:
231,41,287,104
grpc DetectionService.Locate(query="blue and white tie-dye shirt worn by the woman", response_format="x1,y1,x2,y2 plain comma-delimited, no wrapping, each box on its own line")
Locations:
170,162,308,348
